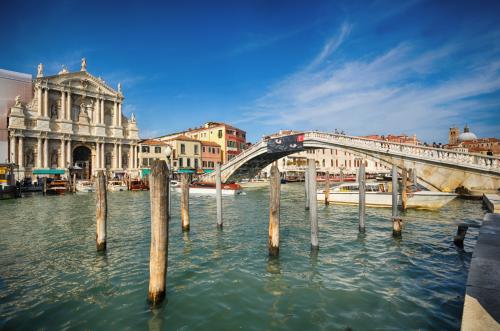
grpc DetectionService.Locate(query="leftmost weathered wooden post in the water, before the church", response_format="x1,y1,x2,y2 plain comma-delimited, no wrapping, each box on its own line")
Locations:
95,170,108,251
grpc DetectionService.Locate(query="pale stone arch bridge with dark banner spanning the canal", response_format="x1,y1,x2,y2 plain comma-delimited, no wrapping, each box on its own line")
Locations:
201,131,500,194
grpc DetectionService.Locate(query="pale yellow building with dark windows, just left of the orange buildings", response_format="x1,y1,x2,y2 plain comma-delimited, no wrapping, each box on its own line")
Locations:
161,134,202,173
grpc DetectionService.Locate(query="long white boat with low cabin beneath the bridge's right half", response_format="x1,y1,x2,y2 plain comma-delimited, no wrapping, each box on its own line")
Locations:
316,183,458,209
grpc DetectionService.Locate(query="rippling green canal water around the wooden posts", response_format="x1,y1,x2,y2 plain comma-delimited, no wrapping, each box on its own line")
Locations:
0,184,484,330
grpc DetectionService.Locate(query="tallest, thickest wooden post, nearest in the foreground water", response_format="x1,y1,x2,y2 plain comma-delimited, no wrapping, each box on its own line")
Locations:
148,161,170,305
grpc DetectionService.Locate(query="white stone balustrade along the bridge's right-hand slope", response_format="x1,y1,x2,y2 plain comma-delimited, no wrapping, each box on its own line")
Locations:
305,132,500,171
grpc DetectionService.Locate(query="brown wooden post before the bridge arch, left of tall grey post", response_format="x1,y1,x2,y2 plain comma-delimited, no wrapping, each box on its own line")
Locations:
267,163,281,256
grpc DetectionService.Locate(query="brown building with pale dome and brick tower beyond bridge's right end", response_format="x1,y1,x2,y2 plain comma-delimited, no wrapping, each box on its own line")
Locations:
444,125,500,156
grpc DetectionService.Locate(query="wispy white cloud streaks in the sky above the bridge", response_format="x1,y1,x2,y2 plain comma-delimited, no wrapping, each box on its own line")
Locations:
247,23,500,139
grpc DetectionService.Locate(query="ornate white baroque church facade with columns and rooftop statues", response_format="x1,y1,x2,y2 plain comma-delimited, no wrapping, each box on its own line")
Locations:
8,58,139,179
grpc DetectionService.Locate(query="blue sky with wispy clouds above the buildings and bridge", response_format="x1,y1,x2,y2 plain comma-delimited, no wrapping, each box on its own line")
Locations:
0,0,500,142
